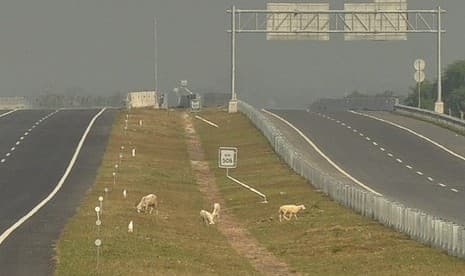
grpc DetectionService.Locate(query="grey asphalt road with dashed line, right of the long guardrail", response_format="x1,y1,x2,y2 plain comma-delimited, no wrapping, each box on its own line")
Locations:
272,110,465,225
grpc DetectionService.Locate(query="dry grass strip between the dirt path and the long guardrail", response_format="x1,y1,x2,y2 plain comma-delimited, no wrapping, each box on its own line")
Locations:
196,110,465,275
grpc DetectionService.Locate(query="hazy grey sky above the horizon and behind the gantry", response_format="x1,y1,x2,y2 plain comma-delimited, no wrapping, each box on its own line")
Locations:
0,0,458,107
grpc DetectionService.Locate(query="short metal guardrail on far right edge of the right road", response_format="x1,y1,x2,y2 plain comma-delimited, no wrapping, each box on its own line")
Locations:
394,104,465,132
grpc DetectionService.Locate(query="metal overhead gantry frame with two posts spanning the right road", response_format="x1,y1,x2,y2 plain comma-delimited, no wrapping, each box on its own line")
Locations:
226,6,446,113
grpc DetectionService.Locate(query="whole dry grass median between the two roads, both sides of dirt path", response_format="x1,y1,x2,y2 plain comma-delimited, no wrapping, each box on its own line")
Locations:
55,109,465,275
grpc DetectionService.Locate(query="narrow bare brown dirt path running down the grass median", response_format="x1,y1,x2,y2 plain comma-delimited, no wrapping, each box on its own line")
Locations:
182,113,296,275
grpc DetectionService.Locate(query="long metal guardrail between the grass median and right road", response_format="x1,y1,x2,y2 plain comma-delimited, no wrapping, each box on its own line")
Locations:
238,101,465,258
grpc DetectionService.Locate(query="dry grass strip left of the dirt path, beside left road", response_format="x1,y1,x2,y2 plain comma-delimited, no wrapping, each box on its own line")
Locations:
55,110,256,275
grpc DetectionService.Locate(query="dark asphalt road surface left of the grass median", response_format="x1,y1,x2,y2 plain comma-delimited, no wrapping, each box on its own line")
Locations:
0,109,116,275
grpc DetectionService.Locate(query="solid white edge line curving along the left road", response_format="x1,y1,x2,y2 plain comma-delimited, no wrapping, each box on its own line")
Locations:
0,108,106,245
